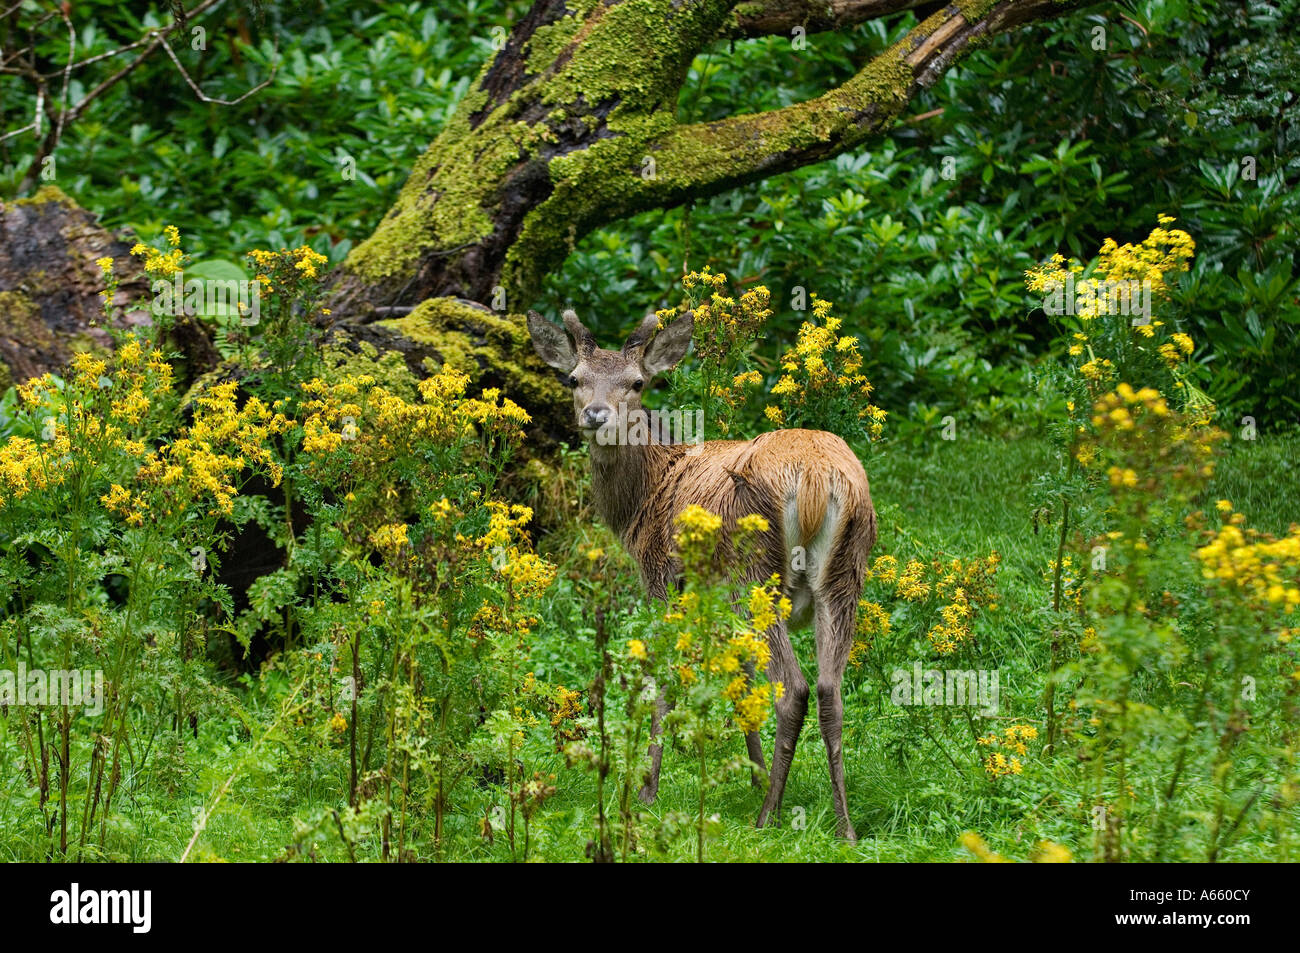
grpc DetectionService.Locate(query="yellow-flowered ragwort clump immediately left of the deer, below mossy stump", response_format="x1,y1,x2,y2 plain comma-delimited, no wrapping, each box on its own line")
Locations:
292,367,555,859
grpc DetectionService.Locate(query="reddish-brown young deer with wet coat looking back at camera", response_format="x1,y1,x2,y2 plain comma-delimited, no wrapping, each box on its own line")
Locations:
528,309,876,841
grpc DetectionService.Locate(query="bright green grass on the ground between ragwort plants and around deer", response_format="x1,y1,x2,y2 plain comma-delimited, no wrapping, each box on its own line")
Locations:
0,426,1300,861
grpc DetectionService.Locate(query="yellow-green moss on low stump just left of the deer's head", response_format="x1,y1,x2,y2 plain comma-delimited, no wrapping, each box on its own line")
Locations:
380,298,568,407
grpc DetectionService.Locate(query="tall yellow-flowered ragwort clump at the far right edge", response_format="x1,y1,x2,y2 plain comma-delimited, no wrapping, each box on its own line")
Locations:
1028,216,1300,862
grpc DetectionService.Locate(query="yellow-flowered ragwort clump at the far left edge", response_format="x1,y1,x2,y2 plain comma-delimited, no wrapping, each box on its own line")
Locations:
0,228,289,857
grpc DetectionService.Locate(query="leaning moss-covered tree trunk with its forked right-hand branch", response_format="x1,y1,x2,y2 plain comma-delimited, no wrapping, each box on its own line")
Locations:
322,0,1084,322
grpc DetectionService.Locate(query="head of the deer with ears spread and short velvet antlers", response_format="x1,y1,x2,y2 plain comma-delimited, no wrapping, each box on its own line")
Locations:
528,311,696,438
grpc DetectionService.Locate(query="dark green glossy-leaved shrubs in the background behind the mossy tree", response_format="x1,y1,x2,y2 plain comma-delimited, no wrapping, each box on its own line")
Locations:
0,0,1300,426
